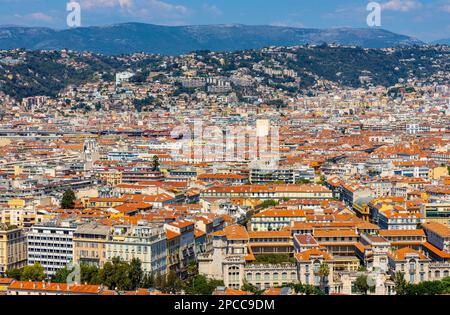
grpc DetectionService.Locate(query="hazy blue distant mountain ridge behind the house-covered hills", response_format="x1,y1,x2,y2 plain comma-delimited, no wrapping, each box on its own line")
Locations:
0,23,425,55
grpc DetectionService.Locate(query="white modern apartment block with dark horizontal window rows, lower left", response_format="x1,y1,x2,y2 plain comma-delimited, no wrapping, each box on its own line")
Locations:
27,221,77,276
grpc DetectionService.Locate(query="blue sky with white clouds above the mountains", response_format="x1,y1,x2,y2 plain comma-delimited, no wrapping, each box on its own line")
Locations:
0,0,450,41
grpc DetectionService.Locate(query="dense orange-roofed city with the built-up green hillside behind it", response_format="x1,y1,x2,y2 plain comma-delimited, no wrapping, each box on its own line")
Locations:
0,40,450,295
